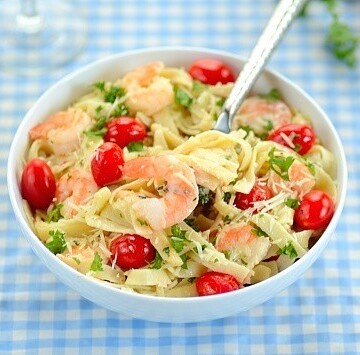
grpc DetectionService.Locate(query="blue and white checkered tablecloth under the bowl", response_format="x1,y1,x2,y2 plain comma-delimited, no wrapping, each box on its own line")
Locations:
0,0,360,355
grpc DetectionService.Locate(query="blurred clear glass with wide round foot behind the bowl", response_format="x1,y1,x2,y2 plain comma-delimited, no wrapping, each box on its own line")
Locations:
0,0,86,75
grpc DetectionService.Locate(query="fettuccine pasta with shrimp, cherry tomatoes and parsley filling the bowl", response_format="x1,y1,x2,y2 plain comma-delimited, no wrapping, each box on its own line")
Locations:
21,59,336,297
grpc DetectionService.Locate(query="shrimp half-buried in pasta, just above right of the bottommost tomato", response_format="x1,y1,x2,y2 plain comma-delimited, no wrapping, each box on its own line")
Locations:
215,223,271,269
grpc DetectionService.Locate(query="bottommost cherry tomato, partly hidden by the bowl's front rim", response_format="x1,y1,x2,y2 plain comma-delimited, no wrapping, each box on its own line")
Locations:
196,271,240,296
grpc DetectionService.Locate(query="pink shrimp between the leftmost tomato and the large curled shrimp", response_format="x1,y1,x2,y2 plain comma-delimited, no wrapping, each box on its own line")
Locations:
55,169,99,218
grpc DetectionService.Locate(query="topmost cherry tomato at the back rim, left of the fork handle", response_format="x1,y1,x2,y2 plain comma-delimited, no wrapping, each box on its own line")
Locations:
189,59,235,85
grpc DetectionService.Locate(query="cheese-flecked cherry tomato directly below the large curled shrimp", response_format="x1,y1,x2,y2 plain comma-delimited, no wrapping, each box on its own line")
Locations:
110,234,156,270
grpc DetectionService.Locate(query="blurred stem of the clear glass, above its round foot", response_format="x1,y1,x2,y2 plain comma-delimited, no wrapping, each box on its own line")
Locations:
16,0,44,34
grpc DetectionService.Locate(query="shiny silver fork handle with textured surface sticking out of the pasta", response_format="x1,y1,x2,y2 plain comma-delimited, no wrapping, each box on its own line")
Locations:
214,0,307,133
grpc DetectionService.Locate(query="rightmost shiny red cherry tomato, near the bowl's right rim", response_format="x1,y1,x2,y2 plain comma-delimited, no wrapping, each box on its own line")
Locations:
294,190,334,229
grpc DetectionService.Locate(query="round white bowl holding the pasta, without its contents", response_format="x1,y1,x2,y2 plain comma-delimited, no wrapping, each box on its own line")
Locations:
7,47,347,322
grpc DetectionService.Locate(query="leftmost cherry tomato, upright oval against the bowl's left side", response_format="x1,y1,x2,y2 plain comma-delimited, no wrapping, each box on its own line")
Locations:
21,158,56,210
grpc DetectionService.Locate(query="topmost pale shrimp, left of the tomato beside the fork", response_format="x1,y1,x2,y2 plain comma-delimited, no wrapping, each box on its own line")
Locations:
121,62,174,116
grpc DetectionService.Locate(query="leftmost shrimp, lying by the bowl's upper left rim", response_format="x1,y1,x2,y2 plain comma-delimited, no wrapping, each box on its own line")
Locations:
30,109,91,155
